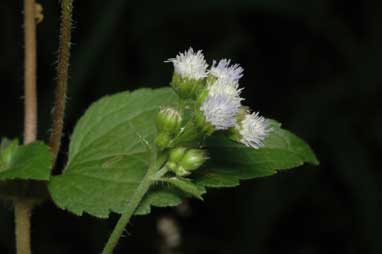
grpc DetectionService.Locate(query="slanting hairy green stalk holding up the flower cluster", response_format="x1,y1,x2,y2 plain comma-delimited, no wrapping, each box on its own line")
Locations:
102,165,167,254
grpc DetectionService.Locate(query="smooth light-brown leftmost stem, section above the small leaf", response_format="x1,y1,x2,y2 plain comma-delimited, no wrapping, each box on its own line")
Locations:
24,0,37,144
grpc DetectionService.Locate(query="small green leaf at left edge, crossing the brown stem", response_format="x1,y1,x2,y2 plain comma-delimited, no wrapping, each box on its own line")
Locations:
0,139,52,181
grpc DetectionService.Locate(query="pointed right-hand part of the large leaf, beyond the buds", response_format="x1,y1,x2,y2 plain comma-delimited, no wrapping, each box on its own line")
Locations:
193,120,318,187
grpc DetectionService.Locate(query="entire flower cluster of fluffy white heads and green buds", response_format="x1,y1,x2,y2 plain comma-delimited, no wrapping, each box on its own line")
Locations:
156,48,271,176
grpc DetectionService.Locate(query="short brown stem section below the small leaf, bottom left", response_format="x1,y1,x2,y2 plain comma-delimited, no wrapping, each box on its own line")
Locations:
14,199,33,254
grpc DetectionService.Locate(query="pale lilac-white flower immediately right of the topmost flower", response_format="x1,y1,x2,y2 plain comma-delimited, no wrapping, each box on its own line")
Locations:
209,59,244,83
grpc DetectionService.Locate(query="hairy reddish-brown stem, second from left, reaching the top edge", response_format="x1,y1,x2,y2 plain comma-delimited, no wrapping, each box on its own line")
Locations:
49,0,73,164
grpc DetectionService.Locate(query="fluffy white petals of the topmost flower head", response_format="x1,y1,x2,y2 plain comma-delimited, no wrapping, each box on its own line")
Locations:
166,48,208,80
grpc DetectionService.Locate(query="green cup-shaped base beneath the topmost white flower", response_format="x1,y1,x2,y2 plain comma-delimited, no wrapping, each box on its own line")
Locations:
171,73,205,99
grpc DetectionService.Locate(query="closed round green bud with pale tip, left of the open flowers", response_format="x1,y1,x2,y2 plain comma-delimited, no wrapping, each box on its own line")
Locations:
156,107,182,134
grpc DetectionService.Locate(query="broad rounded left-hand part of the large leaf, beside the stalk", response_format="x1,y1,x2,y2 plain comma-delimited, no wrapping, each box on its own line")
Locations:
49,88,190,217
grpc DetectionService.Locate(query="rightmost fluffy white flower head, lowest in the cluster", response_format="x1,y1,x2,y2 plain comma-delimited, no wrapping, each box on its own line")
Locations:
239,112,272,149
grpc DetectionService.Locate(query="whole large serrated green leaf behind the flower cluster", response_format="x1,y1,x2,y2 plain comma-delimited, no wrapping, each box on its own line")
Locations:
48,89,316,218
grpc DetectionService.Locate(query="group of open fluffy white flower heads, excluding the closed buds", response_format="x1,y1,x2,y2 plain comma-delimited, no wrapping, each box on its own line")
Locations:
168,48,271,149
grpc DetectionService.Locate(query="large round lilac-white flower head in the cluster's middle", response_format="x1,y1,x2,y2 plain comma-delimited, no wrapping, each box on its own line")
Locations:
200,94,242,130
